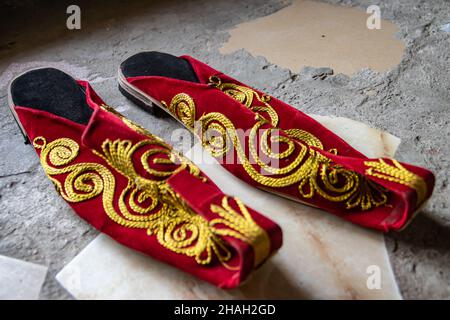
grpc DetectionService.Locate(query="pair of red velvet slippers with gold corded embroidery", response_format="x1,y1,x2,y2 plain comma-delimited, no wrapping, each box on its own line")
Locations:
9,52,434,288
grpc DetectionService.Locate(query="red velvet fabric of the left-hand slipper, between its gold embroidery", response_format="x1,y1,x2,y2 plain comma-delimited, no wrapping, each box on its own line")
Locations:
15,81,282,288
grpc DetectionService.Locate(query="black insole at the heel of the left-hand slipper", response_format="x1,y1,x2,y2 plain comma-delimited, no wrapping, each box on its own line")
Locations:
11,68,93,125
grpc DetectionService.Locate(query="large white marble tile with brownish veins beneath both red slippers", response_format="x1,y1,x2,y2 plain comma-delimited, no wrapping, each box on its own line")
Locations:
57,116,401,299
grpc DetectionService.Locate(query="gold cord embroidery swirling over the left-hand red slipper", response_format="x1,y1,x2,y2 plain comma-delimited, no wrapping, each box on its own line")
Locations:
33,132,270,268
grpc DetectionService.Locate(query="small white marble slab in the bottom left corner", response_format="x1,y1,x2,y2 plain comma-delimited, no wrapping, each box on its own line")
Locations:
0,256,47,300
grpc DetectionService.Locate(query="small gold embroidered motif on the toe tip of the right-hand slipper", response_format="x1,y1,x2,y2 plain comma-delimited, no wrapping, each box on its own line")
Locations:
364,159,427,207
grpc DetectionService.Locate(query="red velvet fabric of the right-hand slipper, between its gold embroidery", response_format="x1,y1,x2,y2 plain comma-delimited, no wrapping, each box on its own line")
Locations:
127,56,434,232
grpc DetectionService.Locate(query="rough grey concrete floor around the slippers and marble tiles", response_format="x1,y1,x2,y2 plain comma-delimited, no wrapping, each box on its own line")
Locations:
0,0,450,299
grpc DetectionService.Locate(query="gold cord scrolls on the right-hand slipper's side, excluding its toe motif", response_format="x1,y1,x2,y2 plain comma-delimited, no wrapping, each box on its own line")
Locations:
161,91,388,210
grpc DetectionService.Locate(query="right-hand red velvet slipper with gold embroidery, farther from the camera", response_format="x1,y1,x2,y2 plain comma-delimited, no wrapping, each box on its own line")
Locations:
118,52,434,231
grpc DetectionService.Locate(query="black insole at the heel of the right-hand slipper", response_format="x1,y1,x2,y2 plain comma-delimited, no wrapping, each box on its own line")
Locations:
120,51,199,83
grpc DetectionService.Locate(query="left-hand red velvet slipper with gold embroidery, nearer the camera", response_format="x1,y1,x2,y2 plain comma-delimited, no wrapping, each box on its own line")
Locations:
9,68,282,288
